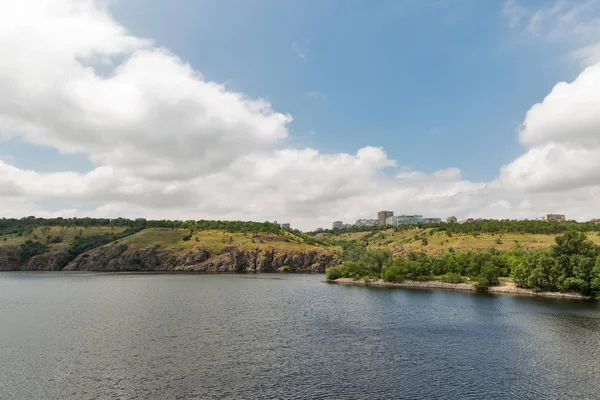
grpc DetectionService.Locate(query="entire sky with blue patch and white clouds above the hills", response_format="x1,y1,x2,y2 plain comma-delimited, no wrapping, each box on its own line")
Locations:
0,0,600,230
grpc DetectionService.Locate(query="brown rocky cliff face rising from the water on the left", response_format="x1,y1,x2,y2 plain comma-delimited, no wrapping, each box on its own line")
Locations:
0,245,339,273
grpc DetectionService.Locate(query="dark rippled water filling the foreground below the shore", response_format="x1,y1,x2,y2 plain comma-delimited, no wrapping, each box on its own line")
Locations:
0,273,600,399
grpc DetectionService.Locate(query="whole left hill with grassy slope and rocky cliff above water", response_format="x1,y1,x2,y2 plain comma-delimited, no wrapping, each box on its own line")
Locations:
0,221,337,272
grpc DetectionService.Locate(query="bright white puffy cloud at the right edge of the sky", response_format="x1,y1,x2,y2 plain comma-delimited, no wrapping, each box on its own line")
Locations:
500,64,600,192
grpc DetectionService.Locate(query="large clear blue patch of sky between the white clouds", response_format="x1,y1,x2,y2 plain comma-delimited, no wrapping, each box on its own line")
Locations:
106,0,576,180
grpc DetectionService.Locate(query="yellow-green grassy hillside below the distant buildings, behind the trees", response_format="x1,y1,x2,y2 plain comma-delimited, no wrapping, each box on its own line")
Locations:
317,228,600,254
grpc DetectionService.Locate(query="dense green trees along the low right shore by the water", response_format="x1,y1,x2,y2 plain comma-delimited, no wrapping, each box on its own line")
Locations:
326,231,600,297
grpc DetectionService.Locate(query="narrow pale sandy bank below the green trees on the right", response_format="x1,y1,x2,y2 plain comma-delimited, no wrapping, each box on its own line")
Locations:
327,278,592,300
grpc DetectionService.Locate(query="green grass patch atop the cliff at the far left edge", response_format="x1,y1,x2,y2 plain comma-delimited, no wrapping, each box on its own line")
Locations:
0,226,126,248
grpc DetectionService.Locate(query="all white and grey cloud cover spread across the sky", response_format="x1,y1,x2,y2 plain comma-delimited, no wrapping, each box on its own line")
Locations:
0,0,600,229
